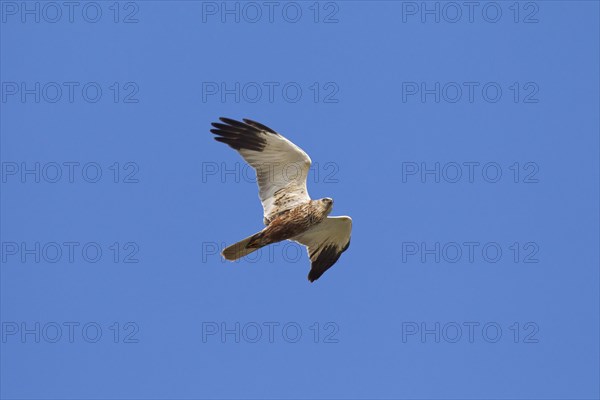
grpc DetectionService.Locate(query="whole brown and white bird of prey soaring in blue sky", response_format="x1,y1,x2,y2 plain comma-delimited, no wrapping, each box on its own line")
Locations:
210,118,352,282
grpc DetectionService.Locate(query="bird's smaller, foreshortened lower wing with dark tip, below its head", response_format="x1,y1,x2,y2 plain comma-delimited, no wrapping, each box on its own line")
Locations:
294,217,352,282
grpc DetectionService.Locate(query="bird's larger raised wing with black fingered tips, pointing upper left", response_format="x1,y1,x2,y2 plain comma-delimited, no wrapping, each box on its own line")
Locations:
210,118,311,225
